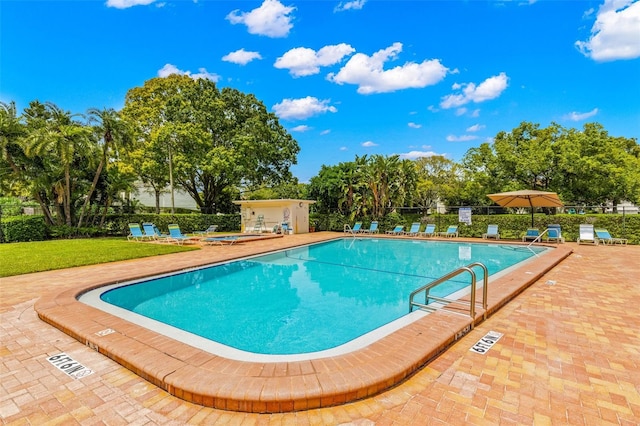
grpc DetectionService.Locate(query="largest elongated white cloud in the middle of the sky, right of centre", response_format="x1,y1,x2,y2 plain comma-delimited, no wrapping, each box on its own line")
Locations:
327,43,449,94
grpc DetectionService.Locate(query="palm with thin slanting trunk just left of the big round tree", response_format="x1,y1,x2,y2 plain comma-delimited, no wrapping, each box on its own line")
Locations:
78,108,133,228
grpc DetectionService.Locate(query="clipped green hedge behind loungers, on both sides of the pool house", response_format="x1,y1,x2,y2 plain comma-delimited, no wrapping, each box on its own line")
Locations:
0,213,640,244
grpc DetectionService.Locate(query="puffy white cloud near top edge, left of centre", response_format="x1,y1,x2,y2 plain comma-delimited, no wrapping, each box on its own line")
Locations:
227,0,296,38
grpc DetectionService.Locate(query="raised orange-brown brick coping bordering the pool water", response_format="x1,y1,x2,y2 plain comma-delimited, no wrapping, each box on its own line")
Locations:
35,233,572,413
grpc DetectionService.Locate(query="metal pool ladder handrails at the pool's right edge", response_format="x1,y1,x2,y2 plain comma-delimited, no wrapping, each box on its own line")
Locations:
409,262,489,328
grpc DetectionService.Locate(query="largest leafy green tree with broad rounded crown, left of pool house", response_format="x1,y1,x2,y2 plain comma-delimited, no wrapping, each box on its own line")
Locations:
123,75,300,213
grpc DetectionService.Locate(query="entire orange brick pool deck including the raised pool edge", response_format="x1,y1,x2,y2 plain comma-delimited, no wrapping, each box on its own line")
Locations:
0,233,640,425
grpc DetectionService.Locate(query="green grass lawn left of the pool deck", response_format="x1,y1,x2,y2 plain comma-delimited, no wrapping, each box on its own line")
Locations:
0,238,198,277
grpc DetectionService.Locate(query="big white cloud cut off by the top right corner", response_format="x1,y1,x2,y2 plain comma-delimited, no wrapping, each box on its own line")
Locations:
575,0,640,61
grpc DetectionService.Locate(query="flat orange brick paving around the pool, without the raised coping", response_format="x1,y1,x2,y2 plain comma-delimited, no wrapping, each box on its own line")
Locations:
0,234,640,425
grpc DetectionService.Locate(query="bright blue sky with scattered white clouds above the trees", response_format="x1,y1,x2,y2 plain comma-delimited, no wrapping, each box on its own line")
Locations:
0,0,640,182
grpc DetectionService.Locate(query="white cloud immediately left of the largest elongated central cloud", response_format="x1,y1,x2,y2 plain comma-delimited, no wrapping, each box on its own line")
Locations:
273,43,355,77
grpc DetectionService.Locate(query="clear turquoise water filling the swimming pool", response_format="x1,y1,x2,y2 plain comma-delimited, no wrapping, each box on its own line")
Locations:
95,238,545,354
